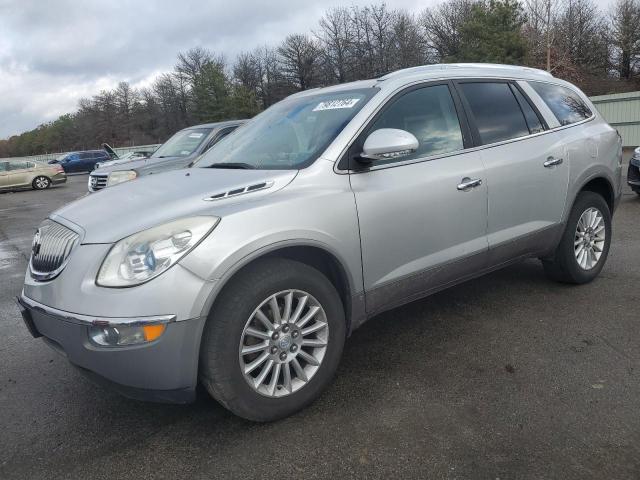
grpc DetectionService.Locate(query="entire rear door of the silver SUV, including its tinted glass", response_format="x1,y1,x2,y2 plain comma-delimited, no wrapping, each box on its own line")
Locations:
457,80,569,265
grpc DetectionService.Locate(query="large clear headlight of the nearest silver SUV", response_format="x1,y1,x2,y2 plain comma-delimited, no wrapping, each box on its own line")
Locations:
96,217,220,287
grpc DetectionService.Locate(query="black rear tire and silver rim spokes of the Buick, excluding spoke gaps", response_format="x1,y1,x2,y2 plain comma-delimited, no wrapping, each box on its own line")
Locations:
542,192,611,284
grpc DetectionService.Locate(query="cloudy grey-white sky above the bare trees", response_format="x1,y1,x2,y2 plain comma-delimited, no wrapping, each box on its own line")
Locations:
0,0,609,138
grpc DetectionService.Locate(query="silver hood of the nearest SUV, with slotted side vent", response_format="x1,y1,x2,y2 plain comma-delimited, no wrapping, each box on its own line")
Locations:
50,168,298,244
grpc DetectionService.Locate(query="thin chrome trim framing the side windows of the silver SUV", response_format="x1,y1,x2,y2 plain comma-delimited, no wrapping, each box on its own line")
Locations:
333,77,596,175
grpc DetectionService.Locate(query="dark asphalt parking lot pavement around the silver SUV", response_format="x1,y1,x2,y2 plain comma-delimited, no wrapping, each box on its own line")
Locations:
0,175,640,479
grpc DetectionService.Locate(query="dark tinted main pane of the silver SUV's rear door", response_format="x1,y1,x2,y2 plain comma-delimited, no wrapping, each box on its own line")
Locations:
459,82,530,145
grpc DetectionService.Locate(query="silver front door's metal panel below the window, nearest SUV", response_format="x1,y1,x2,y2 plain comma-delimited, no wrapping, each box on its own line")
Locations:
351,152,487,312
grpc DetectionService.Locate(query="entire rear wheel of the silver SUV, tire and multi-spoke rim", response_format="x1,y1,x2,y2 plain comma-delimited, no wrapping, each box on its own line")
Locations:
542,192,611,284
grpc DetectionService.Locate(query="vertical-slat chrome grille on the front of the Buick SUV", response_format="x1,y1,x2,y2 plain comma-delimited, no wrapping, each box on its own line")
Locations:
29,220,80,281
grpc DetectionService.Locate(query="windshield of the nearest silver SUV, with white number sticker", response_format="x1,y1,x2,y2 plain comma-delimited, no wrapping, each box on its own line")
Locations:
196,88,378,170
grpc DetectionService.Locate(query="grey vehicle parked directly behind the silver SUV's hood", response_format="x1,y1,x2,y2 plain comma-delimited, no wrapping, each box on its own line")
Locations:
87,120,246,192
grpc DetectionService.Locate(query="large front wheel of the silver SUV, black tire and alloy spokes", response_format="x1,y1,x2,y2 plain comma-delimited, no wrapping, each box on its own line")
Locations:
200,258,346,422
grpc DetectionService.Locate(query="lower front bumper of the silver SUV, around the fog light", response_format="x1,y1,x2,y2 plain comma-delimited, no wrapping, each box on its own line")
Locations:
18,295,205,403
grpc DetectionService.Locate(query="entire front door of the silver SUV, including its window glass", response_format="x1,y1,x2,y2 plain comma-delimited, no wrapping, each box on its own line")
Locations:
351,84,488,313
